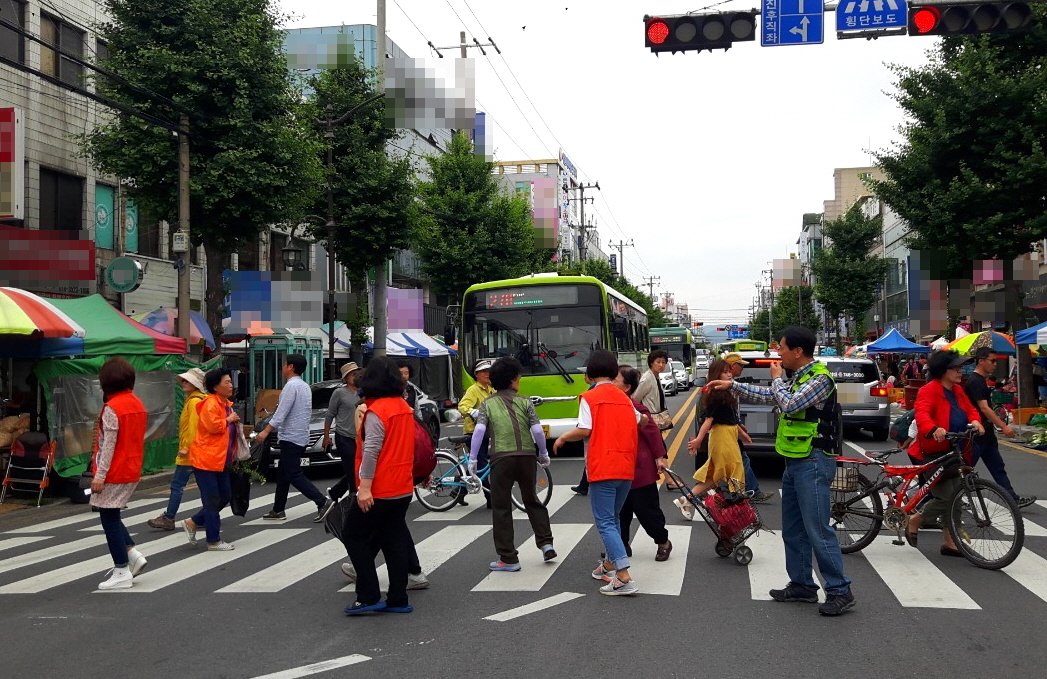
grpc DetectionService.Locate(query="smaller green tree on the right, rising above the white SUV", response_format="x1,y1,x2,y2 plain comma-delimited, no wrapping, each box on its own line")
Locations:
811,203,887,353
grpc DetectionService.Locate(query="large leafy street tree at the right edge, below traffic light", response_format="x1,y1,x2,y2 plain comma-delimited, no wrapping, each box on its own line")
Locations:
873,14,1047,403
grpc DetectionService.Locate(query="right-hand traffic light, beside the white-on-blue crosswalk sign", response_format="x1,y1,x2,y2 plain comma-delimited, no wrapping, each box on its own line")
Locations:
909,2,1032,36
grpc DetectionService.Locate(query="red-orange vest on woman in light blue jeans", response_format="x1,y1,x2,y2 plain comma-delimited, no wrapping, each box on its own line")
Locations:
581,386,638,481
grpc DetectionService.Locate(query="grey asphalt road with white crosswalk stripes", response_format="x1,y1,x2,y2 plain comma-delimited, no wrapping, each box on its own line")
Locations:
0,391,1047,679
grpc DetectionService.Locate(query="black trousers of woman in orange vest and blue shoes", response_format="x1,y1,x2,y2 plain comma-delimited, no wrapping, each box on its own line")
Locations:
343,497,413,606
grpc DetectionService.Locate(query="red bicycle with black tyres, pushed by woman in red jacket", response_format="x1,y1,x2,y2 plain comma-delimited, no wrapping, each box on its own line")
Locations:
830,427,1025,570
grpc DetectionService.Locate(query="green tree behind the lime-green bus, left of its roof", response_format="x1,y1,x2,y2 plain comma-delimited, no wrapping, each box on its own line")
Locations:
415,132,550,299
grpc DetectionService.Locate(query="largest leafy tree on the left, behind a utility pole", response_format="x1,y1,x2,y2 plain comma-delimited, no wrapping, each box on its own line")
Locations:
81,0,322,334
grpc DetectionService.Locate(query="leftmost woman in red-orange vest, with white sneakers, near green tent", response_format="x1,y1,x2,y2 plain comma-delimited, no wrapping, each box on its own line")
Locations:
91,358,149,589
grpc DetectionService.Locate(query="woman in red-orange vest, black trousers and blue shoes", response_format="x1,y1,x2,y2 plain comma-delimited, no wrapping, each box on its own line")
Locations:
342,356,415,615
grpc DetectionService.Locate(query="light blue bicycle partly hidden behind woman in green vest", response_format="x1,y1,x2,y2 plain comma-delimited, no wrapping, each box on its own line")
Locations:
415,434,553,512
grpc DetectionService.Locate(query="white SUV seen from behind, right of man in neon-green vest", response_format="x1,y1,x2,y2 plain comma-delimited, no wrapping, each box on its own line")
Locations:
815,355,891,440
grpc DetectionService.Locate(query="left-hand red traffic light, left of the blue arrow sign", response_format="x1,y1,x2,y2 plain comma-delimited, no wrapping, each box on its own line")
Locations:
644,10,759,54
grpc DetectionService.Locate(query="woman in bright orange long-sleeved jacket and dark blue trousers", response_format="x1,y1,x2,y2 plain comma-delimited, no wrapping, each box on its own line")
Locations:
182,368,240,551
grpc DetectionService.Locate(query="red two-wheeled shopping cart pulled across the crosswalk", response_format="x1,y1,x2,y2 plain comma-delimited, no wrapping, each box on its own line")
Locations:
665,469,763,566
